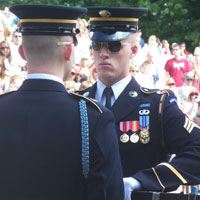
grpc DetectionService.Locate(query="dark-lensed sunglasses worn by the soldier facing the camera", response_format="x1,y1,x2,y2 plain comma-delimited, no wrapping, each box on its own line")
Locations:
92,41,131,53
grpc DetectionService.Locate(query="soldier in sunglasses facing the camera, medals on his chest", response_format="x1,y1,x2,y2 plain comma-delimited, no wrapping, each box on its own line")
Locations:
77,7,200,200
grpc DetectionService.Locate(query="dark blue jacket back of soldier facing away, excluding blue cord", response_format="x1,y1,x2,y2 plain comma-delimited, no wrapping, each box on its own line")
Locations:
0,79,123,200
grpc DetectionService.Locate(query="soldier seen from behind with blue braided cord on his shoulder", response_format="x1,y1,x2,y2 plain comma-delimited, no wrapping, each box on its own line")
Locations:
0,5,124,200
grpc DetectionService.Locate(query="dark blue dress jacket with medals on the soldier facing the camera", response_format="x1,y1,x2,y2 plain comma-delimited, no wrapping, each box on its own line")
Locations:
77,78,200,191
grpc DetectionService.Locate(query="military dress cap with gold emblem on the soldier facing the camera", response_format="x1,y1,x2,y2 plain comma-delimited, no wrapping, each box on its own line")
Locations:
87,7,148,42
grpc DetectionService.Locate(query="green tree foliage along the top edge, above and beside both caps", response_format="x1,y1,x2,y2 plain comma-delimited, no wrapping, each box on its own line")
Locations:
0,0,200,51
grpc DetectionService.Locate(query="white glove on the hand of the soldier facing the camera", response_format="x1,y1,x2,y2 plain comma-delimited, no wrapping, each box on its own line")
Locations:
123,177,141,200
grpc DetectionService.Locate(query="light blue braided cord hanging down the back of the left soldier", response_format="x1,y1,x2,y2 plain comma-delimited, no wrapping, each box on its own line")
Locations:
79,99,90,179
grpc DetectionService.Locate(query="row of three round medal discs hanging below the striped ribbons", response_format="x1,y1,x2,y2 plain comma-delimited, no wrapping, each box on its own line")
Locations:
120,129,150,144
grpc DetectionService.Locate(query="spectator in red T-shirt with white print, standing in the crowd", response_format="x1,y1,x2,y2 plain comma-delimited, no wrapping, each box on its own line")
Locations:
165,44,192,87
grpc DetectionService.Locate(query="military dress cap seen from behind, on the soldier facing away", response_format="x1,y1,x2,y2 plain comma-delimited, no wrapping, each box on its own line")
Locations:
10,5,87,35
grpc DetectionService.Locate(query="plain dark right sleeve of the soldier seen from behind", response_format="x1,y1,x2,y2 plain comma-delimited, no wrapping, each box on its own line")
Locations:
88,110,124,200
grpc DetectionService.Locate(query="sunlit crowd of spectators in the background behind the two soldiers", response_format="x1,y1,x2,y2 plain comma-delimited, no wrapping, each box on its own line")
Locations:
0,7,200,194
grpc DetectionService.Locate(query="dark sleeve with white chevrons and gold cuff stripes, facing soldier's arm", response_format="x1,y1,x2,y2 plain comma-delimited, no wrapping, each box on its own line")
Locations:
133,92,200,192
